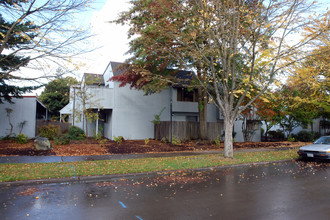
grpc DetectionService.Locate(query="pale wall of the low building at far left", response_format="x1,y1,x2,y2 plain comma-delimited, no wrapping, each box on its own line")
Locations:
0,97,37,138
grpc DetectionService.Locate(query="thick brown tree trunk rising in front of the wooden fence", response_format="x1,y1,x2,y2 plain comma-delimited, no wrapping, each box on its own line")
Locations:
198,88,208,140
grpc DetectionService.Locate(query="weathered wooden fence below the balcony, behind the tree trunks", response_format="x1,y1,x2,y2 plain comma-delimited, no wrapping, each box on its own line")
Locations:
154,121,224,140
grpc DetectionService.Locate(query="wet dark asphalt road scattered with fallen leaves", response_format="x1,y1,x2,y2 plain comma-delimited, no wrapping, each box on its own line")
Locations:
0,161,330,220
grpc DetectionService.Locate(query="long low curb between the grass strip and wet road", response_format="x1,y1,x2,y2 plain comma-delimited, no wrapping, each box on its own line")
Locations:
0,159,296,187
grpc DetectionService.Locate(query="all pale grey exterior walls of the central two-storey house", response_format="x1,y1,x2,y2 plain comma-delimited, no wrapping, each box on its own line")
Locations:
62,63,260,141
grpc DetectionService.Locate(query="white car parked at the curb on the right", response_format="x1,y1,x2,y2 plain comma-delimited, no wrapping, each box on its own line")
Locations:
298,136,330,159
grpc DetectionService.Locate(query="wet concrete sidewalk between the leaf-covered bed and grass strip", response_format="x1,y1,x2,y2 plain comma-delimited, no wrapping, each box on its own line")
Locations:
0,147,292,164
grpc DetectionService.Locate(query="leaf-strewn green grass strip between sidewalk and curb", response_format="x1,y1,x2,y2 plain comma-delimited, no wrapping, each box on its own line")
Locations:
0,149,298,182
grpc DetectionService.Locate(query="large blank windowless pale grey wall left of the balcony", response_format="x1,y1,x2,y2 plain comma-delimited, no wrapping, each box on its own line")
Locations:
108,83,170,139
